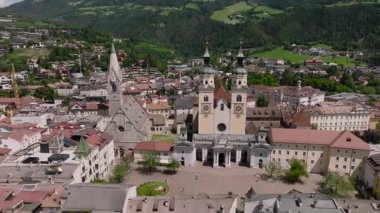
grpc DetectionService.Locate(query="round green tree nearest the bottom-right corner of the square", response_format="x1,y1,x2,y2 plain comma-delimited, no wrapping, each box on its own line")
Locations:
323,172,355,197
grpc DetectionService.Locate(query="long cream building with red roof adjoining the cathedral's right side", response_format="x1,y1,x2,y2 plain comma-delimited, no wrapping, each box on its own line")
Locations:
269,128,370,179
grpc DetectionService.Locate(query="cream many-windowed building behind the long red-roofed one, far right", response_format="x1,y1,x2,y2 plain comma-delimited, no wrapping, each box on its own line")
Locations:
308,101,370,131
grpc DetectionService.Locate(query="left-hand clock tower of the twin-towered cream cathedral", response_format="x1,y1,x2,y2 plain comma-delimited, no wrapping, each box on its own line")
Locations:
198,43,215,134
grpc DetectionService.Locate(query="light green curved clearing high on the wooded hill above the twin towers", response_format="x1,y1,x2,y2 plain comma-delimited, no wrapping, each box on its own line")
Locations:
211,2,253,24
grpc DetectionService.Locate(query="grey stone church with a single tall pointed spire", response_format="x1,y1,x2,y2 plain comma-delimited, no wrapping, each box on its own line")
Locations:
97,44,150,156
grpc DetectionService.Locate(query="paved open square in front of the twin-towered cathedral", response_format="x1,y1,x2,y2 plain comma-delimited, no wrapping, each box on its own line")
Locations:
125,164,323,197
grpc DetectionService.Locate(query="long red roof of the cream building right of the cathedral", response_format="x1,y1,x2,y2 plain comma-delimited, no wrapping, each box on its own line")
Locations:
269,128,370,150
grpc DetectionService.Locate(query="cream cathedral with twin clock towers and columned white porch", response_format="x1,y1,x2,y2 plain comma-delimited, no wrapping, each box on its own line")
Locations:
173,45,271,168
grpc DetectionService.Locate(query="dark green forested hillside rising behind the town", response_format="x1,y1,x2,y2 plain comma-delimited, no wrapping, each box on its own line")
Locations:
3,0,380,56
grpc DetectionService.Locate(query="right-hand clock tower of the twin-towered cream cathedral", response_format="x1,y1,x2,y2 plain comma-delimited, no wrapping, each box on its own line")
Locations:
230,42,248,135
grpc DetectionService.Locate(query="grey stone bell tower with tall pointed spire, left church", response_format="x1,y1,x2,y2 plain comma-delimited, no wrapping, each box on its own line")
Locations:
107,44,123,115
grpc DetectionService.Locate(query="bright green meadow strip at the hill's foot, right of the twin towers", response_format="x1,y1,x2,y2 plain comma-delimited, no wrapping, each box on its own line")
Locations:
252,47,354,67
